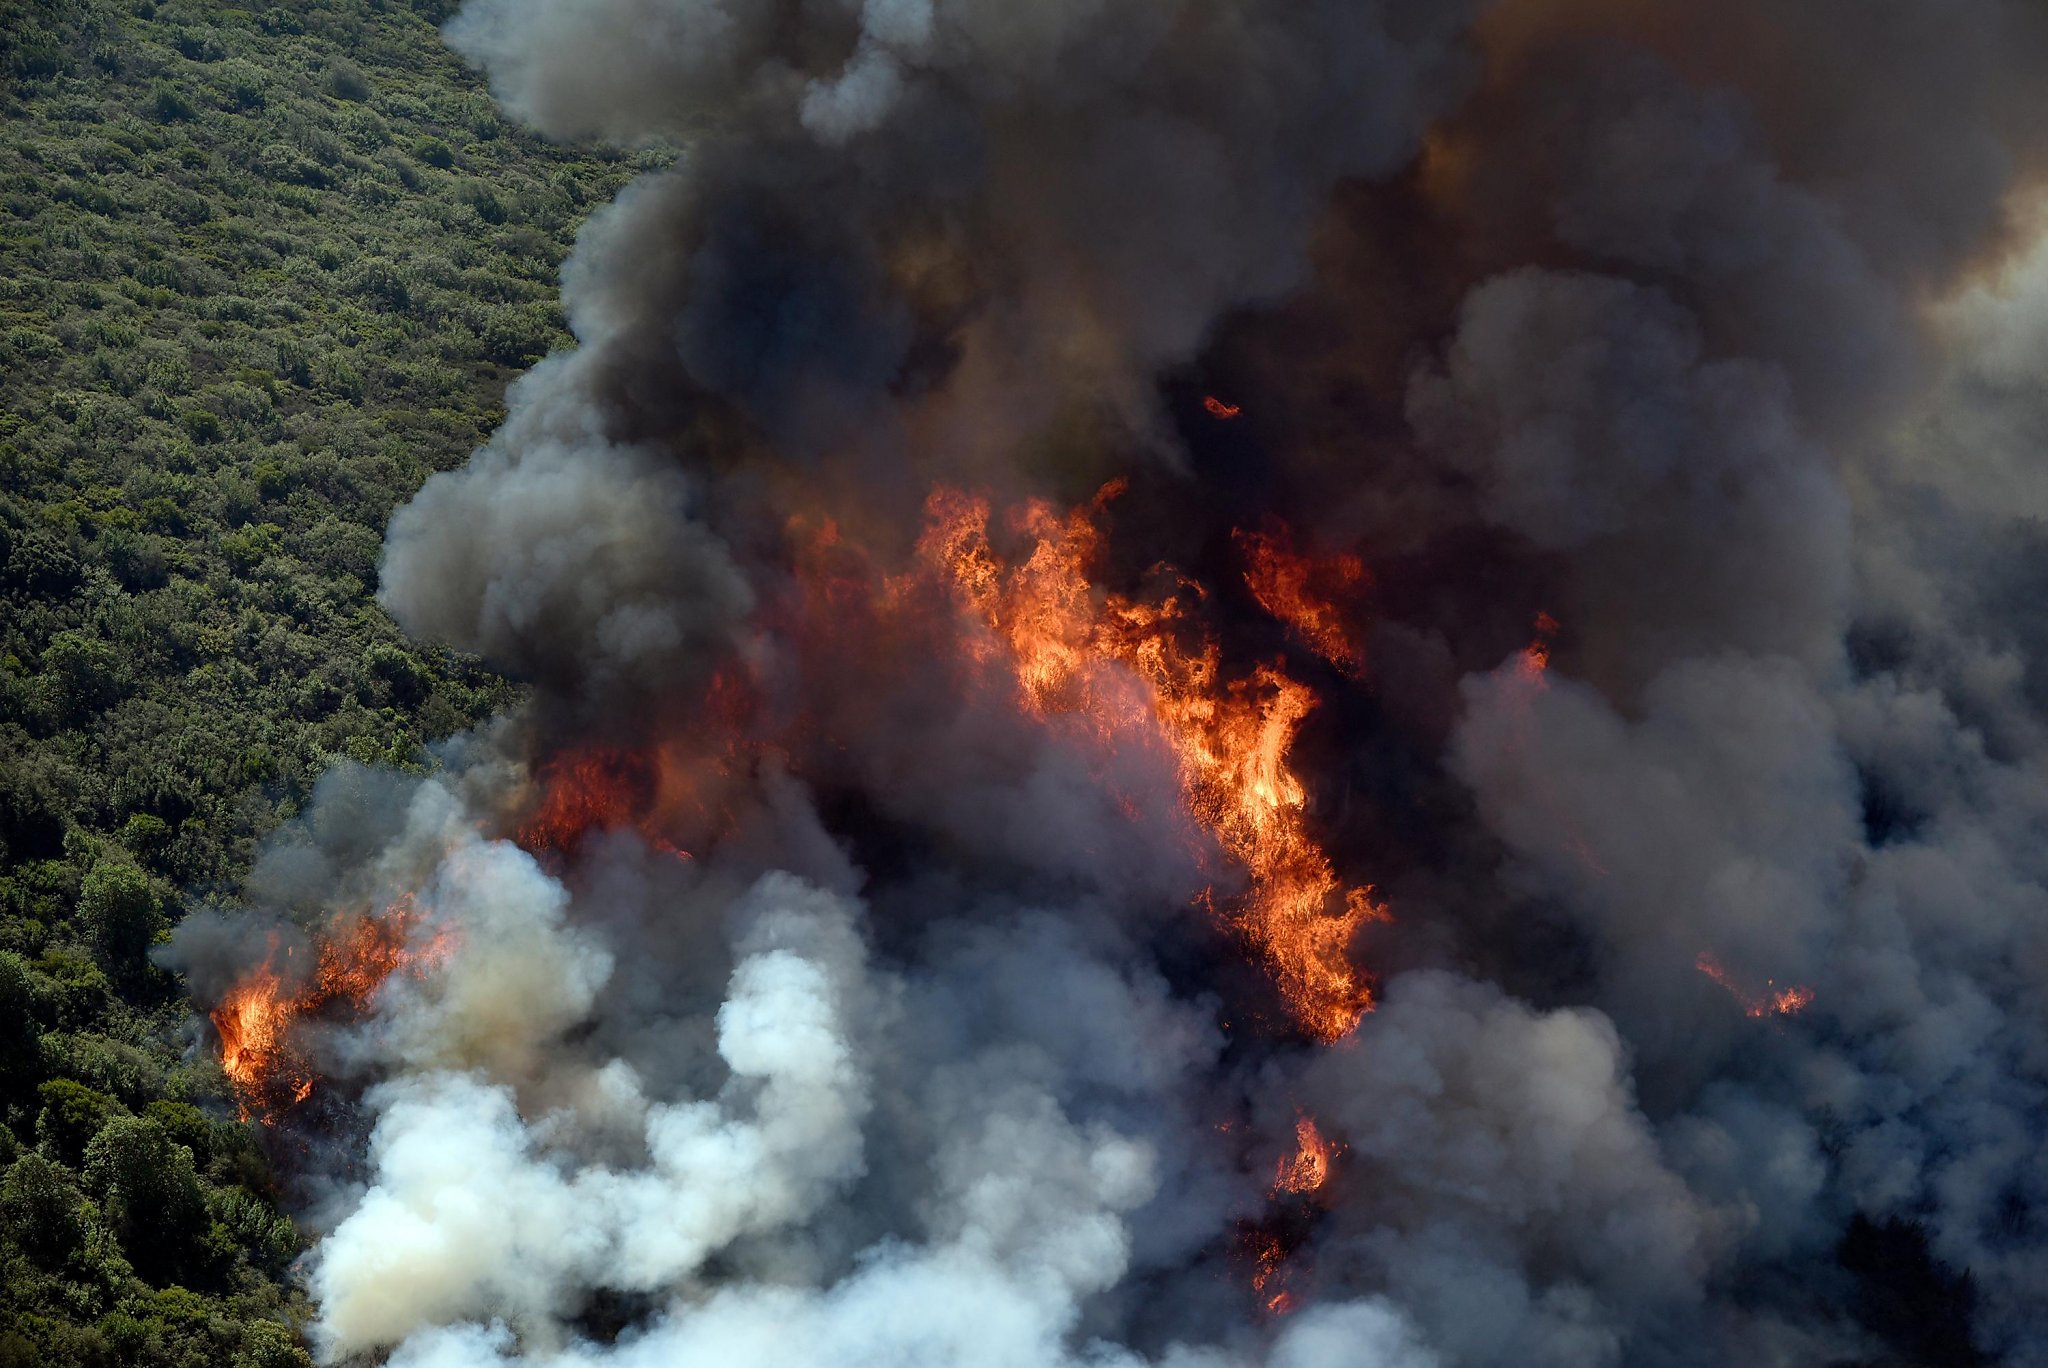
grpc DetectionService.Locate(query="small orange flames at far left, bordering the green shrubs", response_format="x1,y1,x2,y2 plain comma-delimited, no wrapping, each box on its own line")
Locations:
209,895,446,1124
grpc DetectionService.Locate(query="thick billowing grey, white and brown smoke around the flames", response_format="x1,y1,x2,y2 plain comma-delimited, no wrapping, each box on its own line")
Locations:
184,0,2048,1368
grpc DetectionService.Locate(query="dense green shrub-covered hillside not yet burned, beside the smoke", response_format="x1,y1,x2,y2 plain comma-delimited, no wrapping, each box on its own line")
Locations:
0,0,638,1368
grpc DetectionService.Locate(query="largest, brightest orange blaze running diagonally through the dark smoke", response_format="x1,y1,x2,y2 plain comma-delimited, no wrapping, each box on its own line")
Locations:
920,483,1386,1040
